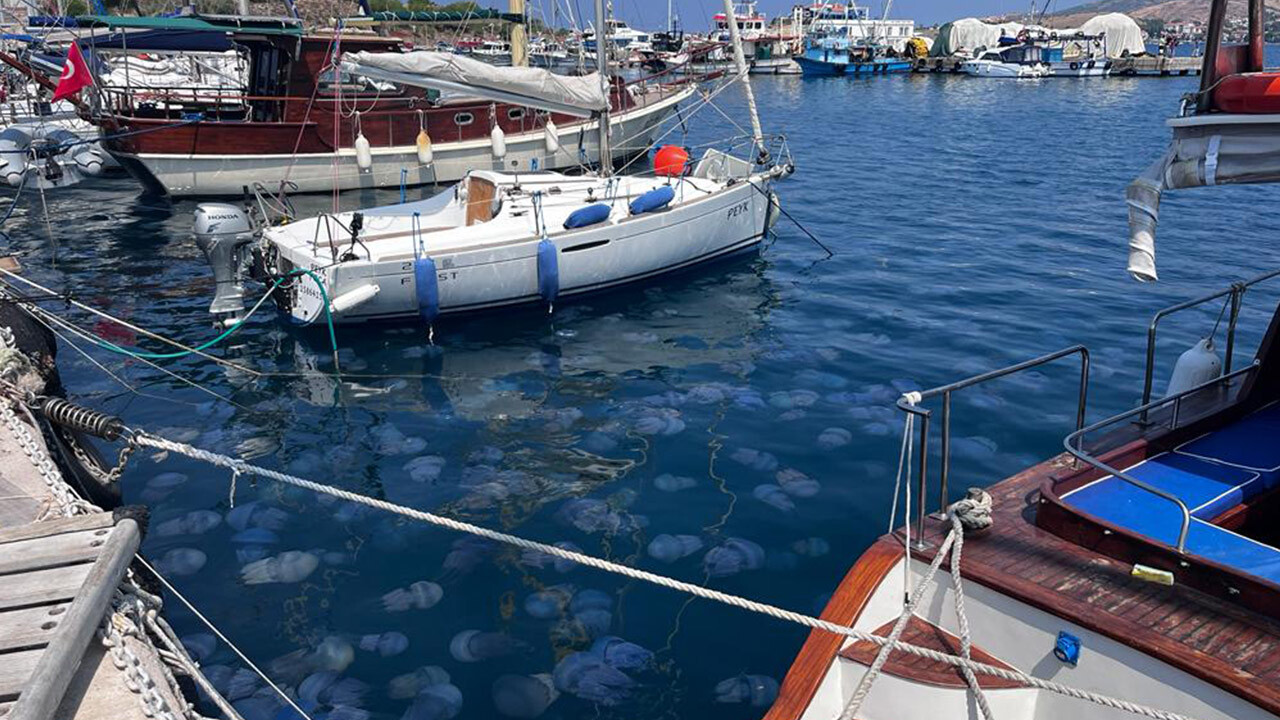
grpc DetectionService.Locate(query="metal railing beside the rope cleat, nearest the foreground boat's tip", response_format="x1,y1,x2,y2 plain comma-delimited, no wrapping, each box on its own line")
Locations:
897,345,1089,546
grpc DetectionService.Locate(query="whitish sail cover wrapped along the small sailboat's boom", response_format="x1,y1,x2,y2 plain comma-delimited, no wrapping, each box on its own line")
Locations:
342,50,609,118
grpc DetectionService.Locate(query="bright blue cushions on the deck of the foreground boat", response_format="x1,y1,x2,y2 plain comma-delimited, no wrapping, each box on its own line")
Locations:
1062,448,1280,584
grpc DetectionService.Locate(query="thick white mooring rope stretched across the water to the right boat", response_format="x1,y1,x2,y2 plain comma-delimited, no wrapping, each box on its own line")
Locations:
131,430,1208,720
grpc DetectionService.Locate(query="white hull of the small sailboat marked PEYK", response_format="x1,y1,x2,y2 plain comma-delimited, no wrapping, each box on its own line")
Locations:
254,167,773,323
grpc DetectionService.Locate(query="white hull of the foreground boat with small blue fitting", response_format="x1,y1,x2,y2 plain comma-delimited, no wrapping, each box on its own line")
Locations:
800,560,1274,720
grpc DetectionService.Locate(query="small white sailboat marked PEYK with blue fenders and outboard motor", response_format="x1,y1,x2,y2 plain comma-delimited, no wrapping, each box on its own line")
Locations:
196,2,792,325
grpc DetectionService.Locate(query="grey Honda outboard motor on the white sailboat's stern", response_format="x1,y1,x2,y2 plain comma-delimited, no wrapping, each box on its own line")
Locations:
195,202,257,315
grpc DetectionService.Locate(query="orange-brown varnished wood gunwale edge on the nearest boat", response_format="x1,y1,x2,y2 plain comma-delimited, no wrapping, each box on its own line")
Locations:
764,536,902,720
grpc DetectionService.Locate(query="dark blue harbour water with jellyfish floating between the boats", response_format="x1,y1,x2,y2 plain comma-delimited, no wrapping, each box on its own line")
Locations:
4,67,1280,720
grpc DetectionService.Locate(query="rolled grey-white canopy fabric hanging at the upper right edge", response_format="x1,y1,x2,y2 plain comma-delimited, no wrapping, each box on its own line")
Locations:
1125,113,1280,282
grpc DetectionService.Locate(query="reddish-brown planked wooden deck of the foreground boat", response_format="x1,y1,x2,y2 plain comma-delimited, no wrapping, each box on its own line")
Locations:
916,456,1280,715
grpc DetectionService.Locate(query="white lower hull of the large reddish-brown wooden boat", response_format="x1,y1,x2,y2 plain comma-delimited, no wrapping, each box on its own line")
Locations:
118,87,694,196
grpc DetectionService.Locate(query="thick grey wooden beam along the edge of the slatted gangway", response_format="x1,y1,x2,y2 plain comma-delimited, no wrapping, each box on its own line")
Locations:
8,520,141,720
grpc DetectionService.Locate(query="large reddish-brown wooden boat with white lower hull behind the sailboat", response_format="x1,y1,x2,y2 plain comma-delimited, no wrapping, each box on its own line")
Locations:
90,12,695,196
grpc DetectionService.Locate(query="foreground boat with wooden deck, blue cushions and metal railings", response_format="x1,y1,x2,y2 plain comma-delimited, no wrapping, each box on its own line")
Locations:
767,0,1280,720
